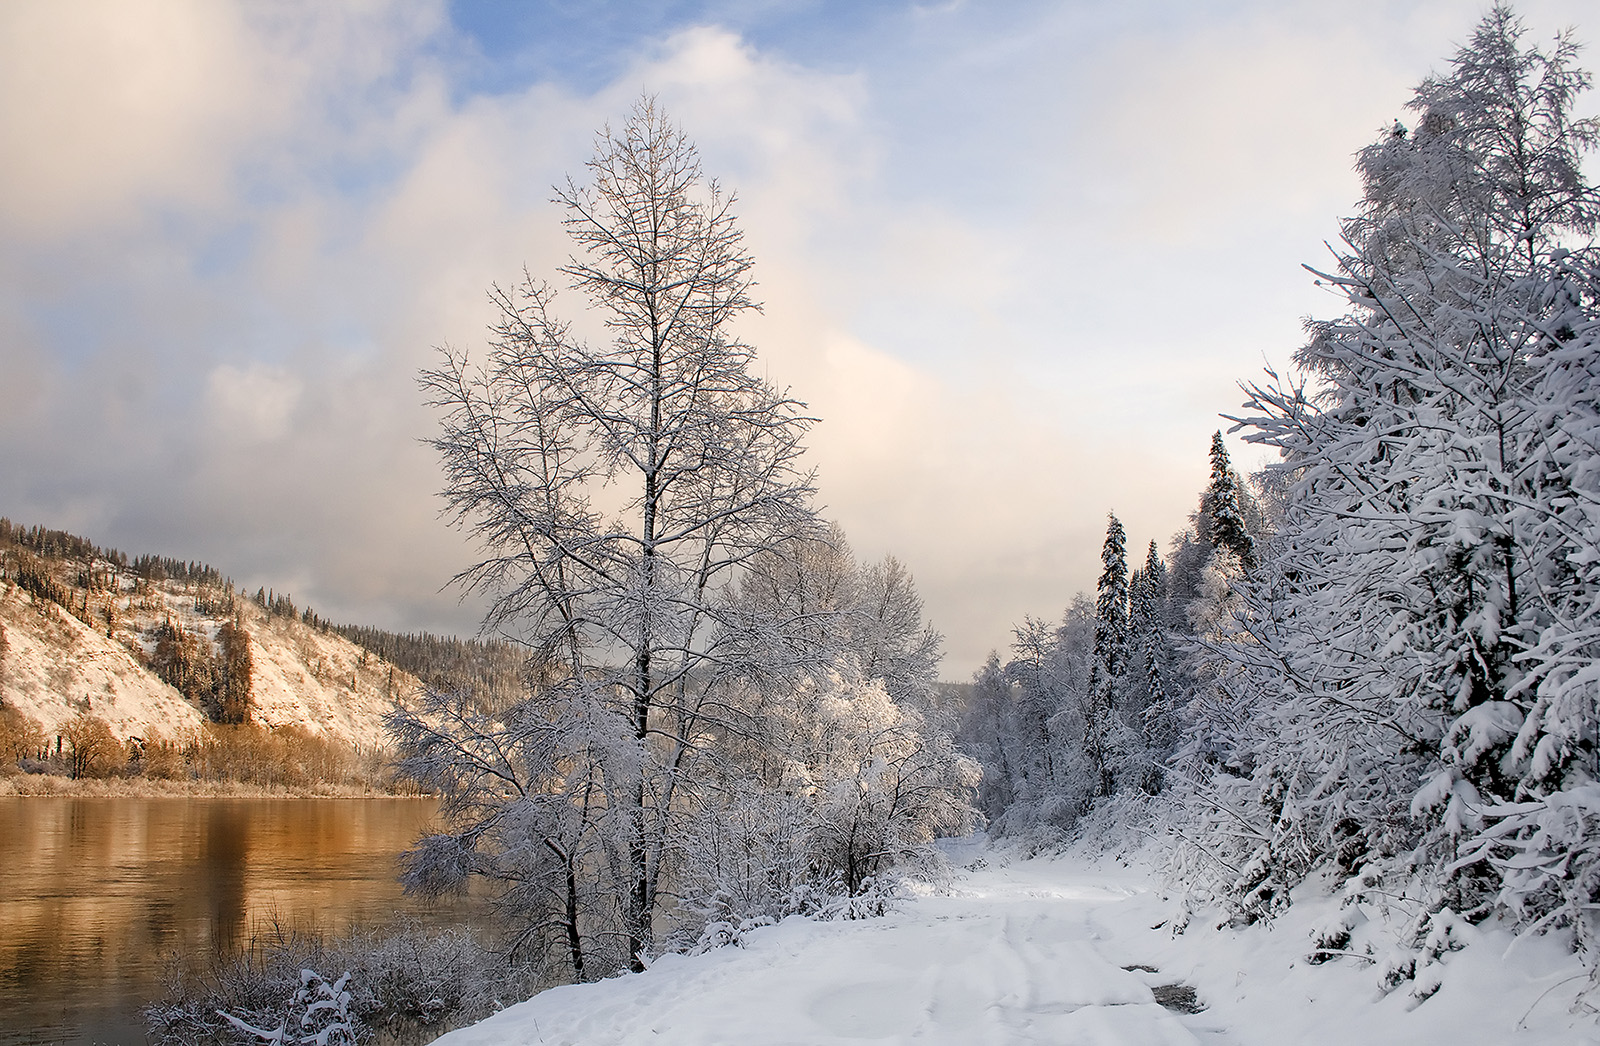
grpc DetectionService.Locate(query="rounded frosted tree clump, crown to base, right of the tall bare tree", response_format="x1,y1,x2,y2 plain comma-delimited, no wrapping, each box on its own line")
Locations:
675,526,978,934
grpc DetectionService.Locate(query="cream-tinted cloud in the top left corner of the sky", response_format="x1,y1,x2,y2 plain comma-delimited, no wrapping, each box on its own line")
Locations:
0,0,443,240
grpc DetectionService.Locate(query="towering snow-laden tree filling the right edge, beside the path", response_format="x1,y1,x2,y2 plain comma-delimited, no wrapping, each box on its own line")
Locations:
1177,6,1600,985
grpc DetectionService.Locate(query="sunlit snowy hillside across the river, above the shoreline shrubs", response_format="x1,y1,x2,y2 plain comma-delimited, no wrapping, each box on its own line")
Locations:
0,520,480,752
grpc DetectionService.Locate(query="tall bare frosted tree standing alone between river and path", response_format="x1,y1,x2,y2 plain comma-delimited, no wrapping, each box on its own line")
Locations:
394,99,814,976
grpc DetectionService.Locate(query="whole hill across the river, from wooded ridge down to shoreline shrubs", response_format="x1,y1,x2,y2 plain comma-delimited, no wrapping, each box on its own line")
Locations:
0,518,522,790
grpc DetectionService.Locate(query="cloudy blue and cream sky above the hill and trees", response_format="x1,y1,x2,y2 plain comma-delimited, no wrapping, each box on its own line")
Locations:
0,0,1600,681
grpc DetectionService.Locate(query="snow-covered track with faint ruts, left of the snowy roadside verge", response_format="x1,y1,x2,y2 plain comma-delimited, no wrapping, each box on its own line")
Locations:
438,852,1219,1046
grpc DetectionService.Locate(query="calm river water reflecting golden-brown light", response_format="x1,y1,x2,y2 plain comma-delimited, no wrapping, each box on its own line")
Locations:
0,796,480,1046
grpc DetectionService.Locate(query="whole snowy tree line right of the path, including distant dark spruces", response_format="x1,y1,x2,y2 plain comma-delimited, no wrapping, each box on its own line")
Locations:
963,6,1600,1000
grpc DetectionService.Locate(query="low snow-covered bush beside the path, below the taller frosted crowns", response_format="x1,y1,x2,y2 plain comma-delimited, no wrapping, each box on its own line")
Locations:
675,659,979,948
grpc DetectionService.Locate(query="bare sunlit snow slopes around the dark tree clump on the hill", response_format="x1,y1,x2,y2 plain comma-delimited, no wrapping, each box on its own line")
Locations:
0,581,419,750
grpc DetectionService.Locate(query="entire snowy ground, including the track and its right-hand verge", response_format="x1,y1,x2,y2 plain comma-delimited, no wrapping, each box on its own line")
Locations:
438,841,1600,1046
